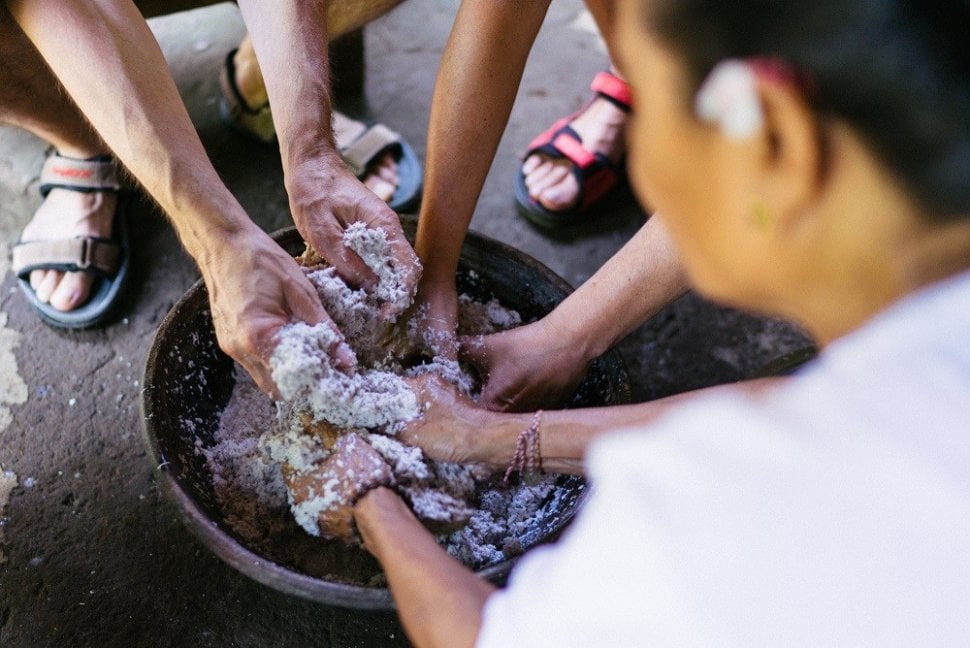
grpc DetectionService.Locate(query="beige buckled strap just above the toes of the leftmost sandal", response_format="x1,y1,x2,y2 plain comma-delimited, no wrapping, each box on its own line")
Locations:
12,236,121,277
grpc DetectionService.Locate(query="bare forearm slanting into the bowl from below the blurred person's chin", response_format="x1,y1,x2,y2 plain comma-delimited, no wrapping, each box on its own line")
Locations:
545,216,687,361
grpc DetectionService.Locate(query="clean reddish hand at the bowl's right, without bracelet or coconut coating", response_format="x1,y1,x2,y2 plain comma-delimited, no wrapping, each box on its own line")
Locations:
460,320,589,412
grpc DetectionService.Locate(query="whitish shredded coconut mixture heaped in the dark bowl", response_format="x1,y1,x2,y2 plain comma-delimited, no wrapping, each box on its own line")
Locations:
205,223,568,568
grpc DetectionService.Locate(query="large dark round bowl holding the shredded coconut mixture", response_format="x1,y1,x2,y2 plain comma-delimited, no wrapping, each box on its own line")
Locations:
142,219,630,609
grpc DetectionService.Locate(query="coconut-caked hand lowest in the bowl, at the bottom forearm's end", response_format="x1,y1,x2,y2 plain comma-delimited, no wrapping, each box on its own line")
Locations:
284,433,394,544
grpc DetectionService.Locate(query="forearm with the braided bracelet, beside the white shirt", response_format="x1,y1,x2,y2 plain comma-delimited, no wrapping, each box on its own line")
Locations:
467,378,785,474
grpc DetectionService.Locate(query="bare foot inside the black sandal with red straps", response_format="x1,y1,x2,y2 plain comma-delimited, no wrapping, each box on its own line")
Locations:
522,97,627,212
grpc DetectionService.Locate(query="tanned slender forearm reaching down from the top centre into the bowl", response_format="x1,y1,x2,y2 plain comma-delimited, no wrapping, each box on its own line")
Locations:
415,0,549,281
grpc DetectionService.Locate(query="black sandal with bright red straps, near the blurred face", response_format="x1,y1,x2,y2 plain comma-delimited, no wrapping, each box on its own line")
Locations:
515,72,632,229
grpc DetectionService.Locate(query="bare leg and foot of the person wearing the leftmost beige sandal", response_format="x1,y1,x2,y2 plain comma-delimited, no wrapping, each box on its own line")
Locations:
0,4,118,311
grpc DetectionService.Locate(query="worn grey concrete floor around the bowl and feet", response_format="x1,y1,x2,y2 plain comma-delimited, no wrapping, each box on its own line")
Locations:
0,0,805,648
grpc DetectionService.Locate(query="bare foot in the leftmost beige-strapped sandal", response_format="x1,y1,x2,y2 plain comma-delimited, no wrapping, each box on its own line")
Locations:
20,188,118,311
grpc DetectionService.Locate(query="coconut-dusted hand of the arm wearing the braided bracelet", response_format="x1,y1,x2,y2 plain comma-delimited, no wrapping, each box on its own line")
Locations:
398,374,489,463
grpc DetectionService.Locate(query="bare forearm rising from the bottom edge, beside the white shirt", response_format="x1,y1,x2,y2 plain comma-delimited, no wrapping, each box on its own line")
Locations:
355,488,495,648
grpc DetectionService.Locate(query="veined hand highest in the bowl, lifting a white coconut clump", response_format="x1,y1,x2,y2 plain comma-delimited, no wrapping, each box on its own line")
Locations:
286,153,421,320
